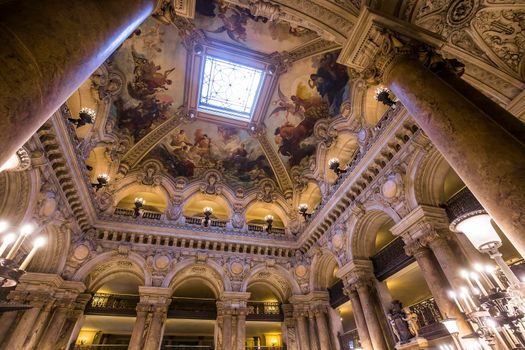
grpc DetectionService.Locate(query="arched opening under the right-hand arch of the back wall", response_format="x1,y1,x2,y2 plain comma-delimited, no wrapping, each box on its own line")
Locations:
246,282,284,349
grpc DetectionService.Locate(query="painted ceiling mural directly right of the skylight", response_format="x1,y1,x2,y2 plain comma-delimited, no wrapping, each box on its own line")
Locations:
265,52,349,167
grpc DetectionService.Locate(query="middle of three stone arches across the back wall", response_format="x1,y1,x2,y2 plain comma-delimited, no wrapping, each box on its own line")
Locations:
162,259,231,299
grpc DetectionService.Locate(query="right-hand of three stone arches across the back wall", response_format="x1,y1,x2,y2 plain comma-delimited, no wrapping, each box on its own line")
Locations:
241,264,301,302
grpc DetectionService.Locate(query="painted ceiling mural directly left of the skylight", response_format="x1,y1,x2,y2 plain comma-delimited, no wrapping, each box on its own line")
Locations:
112,18,186,142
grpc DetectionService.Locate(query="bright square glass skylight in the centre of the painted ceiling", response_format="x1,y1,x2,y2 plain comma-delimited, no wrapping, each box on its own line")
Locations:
197,53,266,122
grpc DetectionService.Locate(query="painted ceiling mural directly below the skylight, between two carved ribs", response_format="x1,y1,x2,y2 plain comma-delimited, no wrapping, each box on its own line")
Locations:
141,121,277,188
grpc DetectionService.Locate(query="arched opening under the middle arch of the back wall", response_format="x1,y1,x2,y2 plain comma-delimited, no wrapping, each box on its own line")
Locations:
162,277,217,349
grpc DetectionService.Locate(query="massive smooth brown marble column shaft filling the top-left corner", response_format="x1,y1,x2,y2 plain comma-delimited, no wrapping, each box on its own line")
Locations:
0,0,157,164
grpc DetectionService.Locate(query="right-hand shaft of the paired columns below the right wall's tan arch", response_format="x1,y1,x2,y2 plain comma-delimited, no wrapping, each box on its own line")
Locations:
357,281,388,350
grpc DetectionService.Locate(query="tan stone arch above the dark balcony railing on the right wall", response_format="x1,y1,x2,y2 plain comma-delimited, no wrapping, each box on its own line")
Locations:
348,204,401,259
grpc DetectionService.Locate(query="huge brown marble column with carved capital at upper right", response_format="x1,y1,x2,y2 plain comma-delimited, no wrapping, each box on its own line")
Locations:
339,9,525,256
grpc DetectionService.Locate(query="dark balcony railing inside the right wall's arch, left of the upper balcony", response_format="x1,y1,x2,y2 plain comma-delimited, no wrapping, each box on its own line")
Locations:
372,238,415,281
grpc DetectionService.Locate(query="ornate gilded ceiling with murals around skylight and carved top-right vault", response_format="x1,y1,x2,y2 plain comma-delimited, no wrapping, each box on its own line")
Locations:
57,0,525,243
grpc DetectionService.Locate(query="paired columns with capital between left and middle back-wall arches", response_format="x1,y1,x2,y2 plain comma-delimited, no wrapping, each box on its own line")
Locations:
128,287,171,350
